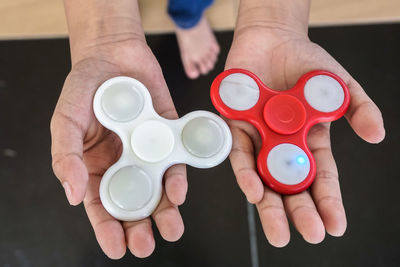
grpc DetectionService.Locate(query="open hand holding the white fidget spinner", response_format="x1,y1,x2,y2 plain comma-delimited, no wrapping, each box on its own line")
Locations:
51,38,187,259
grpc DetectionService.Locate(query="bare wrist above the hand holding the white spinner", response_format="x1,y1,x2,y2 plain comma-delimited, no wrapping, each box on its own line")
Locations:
64,0,146,65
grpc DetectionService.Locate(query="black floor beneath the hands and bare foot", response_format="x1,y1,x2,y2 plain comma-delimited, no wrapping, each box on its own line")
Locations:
0,25,400,267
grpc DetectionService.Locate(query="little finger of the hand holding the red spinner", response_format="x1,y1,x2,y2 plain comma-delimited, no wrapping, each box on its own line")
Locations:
229,127,264,203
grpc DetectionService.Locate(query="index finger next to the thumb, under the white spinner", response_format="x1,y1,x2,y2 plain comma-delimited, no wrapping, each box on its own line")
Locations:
84,173,126,259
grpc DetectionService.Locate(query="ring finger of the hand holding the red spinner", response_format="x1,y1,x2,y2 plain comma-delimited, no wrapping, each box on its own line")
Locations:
256,187,290,247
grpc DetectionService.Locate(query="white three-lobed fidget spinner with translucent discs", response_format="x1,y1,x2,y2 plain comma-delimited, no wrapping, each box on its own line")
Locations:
93,77,232,221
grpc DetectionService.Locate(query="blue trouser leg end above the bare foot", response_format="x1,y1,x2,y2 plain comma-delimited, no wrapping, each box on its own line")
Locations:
168,0,214,29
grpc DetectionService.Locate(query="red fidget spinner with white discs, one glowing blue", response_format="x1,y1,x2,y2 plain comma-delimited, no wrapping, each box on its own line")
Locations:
211,69,350,194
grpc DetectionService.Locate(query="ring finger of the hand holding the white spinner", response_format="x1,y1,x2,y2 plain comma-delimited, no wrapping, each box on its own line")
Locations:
152,194,184,242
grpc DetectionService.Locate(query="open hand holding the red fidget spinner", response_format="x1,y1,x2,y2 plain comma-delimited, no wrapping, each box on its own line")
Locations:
226,24,385,247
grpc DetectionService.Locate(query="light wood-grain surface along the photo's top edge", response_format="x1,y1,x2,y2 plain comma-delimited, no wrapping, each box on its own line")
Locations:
0,0,400,39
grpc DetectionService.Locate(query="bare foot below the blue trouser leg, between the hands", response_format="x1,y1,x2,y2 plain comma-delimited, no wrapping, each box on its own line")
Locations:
176,16,219,79
